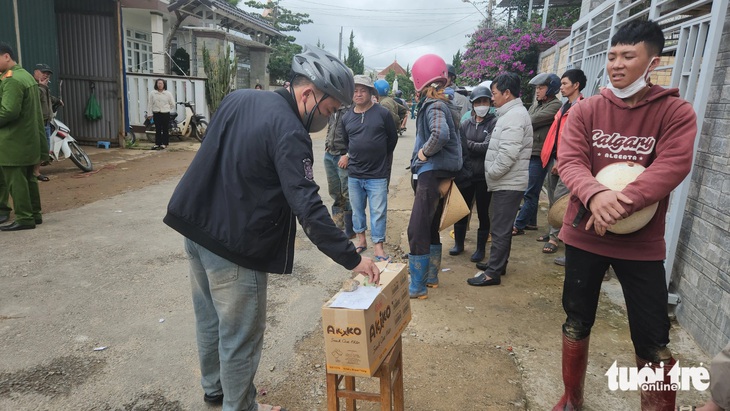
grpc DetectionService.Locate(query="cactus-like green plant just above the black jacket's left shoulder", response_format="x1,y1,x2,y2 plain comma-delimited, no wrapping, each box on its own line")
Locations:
203,44,238,116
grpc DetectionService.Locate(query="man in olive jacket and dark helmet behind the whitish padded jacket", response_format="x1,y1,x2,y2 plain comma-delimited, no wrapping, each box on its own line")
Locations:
512,73,561,245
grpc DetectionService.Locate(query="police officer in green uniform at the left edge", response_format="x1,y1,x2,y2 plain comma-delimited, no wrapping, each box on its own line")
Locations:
0,42,48,231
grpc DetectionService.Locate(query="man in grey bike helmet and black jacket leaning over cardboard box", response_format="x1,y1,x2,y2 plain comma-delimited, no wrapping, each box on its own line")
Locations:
164,46,380,411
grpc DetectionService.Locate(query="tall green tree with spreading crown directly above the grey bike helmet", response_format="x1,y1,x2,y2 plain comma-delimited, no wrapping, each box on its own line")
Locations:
244,0,312,84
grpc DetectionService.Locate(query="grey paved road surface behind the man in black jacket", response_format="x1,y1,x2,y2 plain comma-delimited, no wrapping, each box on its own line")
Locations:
0,127,413,410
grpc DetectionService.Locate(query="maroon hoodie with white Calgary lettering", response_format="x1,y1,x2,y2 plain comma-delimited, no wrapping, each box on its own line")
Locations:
558,86,697,261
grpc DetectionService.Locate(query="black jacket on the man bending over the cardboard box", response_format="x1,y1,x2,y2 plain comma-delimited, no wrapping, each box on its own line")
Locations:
164,89,361,274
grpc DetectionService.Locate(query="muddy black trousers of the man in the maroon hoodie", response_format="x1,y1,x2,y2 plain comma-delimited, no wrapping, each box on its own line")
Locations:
563,245,670,361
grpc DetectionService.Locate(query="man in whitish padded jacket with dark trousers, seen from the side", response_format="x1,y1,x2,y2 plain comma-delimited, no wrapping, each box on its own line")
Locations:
467,73,532,286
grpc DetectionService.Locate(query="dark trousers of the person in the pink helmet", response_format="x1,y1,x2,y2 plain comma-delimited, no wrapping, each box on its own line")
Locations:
408,171,444,255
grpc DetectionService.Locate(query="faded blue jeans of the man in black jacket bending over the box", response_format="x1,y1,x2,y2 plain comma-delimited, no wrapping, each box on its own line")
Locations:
185,238,267,411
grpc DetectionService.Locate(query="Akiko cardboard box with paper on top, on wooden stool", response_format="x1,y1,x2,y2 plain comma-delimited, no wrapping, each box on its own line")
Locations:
322,262,411,377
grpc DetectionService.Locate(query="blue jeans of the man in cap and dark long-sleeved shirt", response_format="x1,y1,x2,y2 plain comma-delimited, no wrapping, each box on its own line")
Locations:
347,177,388,244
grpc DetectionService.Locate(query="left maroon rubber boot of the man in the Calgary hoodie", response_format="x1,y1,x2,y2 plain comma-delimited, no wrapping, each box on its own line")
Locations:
553,334,591,411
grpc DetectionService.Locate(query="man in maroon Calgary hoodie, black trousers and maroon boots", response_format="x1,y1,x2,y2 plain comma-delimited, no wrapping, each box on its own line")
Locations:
554,20,697,411
